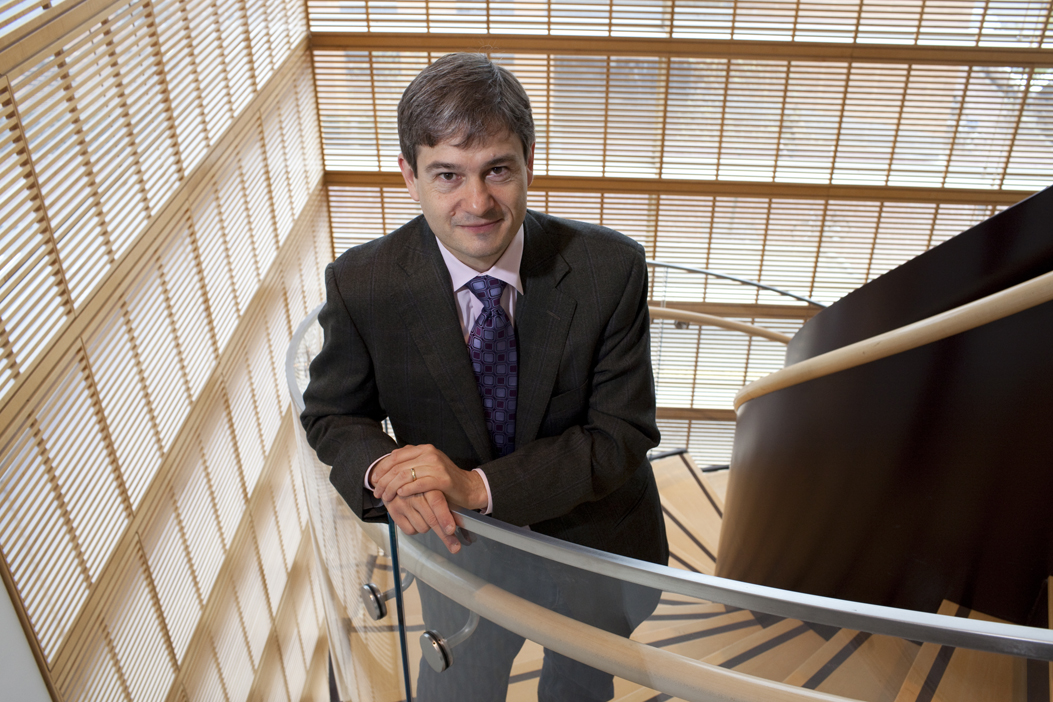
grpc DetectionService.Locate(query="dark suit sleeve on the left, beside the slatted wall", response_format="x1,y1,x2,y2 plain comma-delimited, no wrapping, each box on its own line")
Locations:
300,263,396,520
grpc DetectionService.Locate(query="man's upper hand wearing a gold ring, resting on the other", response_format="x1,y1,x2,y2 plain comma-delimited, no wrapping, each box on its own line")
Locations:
370,444,486,512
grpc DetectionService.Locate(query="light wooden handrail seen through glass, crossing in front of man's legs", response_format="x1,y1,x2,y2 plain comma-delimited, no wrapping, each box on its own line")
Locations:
399,532,848,702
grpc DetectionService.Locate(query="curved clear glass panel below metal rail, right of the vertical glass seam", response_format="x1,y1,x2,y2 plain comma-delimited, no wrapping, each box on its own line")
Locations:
398,511,1050,702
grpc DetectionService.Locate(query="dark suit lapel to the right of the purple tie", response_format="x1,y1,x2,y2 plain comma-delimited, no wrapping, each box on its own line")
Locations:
515,213,577,446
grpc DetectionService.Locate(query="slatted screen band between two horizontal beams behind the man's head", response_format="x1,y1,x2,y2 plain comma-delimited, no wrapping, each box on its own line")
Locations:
315,49,1053,192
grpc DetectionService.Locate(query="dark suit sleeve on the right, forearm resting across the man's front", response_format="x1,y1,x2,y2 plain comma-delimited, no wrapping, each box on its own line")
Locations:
482,250,660,524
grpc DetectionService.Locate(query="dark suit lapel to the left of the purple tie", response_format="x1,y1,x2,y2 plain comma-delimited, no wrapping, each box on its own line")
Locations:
398,218,494,463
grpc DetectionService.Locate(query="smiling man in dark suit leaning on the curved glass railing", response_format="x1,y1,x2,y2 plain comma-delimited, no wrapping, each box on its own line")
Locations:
301,54,669,700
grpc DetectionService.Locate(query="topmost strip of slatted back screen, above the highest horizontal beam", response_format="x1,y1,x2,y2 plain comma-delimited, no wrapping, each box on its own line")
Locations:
307,0,1050,46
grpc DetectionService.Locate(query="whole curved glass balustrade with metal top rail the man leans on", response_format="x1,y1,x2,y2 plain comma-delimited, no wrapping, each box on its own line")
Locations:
286,271,1053,702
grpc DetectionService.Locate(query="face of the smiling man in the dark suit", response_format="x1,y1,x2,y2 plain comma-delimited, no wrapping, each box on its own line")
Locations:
398,133,534,273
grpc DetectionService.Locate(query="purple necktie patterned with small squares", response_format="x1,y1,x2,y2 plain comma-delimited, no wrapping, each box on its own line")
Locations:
468,276,518,457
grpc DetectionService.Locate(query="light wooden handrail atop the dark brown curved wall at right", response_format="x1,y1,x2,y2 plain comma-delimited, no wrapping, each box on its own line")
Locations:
735,272,1053,409
